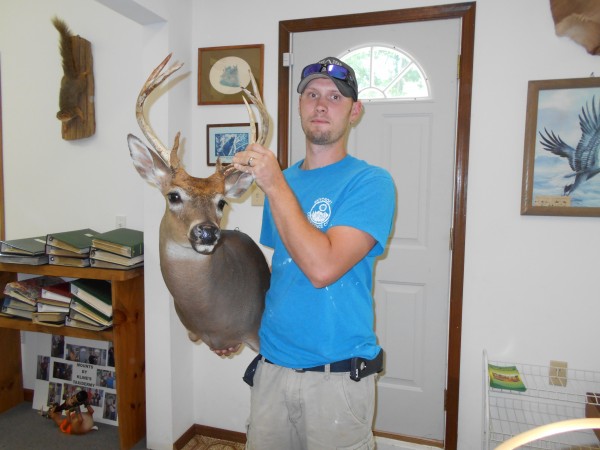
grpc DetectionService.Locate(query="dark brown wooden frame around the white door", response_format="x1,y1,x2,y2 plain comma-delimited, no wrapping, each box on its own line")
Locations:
277,2,475,450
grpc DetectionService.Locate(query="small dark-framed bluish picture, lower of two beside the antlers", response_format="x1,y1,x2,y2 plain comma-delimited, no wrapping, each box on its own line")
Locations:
206,123,251,166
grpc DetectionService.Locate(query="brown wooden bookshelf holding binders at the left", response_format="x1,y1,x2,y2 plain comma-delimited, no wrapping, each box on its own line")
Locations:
0,263,146,450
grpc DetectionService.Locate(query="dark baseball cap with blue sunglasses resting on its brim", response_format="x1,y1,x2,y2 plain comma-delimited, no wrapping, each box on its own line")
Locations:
298,56,358,101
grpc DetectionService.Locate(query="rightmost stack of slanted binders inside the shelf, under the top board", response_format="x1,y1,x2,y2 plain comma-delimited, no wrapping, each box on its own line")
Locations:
65,278,113,330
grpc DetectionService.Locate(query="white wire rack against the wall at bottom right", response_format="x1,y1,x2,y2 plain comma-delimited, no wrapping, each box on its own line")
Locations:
483,352,600,450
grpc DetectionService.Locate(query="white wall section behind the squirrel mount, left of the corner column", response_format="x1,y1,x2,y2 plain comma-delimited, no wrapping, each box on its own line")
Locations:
0,0,144,238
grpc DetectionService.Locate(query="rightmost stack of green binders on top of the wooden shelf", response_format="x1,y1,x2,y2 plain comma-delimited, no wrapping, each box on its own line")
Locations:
90,228,144,270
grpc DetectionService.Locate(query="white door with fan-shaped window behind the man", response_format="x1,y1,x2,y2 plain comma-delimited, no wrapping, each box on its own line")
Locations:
289,19,460,441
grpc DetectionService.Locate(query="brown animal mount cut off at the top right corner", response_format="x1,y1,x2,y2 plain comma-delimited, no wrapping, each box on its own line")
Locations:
550,0,600,55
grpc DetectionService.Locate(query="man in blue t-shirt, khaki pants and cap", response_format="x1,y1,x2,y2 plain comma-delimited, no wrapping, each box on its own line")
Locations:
233,57,395,450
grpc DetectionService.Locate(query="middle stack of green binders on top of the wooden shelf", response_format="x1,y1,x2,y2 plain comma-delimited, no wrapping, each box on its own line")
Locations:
45,228,99,267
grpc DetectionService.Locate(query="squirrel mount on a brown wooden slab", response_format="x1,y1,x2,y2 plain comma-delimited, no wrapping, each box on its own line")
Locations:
52,17,96,141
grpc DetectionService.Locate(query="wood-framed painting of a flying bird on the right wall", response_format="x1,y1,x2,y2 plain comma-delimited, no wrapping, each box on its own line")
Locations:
521,78,600,216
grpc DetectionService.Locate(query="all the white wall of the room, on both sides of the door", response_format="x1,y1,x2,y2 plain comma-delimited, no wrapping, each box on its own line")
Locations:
0,0,600,450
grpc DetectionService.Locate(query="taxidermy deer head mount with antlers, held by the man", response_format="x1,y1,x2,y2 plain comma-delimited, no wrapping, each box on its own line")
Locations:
127,55,270,351
